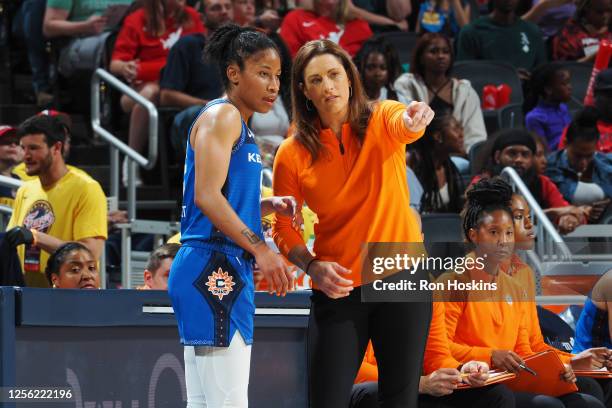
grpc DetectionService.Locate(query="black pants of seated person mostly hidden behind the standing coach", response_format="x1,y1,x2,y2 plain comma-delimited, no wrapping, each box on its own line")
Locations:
349,382,515,408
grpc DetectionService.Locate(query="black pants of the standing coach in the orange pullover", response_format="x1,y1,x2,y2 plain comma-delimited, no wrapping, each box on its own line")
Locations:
308,288,432,408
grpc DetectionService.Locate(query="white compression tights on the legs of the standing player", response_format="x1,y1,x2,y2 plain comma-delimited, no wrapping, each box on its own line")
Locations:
185,331,251,408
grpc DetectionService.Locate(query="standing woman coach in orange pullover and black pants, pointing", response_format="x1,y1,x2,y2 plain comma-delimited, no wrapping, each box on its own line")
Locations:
273,40,433,408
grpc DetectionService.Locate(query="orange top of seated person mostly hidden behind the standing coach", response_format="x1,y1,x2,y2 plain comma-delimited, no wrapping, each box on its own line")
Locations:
355,302,461,384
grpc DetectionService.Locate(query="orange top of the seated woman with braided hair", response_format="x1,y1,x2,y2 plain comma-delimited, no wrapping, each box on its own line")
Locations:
438,262,533,366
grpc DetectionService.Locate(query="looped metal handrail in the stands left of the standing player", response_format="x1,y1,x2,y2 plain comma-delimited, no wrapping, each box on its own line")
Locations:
91,68,158,220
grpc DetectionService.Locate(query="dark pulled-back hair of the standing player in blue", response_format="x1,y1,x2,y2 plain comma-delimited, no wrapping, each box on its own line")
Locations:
204,24,280,89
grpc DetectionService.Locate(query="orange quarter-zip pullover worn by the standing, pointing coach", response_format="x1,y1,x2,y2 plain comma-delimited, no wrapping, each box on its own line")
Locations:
273,101,424,286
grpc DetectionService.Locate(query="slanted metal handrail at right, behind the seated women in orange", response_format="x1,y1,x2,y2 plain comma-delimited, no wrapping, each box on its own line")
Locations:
501,167,572,261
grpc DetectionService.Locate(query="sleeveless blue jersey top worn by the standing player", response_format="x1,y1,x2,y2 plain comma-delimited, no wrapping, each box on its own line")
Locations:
181,99,263,250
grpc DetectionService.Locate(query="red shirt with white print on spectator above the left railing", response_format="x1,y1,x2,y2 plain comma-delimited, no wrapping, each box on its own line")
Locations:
112,6,204,82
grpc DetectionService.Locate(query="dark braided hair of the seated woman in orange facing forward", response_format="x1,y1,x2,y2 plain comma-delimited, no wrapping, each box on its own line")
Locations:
461,177,512,242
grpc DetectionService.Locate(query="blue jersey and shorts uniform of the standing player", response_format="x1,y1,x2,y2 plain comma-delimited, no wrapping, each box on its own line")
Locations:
168,99,263,347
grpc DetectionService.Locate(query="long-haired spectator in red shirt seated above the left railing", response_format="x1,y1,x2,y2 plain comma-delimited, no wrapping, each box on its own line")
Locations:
110,0,204,185
